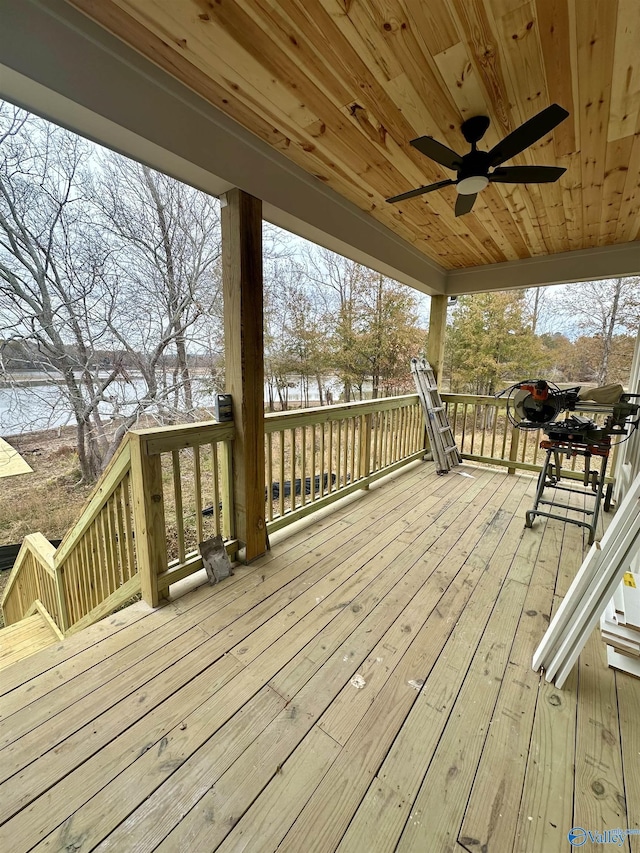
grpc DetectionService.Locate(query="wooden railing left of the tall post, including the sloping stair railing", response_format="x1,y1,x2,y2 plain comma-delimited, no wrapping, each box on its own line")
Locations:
2,422,237,634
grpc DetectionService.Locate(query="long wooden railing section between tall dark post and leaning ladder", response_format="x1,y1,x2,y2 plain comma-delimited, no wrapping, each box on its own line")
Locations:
265,394,425,531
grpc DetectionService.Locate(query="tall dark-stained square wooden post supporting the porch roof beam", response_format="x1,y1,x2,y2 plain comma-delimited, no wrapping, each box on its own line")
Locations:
221,189,267,562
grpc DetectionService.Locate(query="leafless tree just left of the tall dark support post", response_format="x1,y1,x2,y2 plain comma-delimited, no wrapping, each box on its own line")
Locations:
101,154,222,420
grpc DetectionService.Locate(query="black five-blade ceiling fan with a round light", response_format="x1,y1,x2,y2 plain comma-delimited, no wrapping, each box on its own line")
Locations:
387,104,569,216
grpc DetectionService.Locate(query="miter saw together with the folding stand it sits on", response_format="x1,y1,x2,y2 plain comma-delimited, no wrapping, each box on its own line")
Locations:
496,379,640,544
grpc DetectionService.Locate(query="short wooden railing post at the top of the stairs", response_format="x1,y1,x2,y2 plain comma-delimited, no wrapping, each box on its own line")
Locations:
130,432,167,607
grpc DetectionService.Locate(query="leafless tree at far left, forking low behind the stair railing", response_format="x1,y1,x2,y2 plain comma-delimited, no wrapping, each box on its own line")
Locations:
0,105,124,479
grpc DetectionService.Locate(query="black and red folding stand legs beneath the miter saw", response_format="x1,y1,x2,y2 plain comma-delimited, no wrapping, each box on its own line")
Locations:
525,439,612,545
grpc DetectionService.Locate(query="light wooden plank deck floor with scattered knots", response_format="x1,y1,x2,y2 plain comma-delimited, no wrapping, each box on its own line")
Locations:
0,464,640,853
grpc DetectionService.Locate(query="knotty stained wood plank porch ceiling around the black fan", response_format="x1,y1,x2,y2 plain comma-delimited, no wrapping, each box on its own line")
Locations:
69,0,640,269
